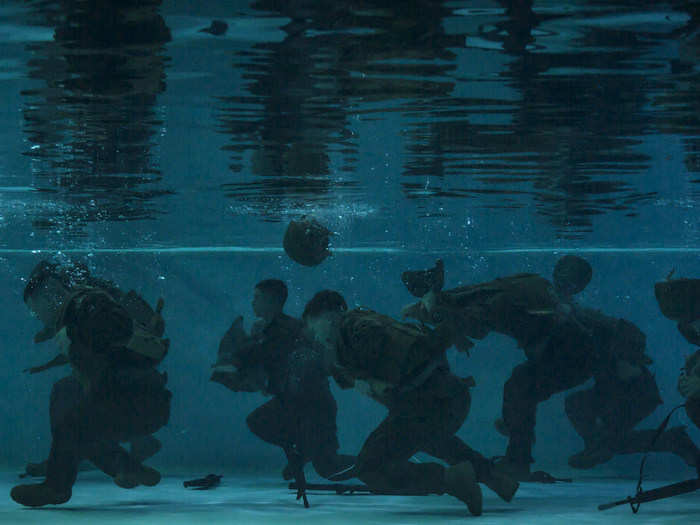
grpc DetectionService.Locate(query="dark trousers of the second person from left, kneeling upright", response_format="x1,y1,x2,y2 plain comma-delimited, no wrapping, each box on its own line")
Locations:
246,380,355,479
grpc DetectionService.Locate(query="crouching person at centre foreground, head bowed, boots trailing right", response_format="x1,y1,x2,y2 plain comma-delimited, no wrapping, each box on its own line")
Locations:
303,290,518,515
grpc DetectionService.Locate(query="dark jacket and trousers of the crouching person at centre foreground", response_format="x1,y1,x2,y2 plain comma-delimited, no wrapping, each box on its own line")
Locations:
333,309,500,494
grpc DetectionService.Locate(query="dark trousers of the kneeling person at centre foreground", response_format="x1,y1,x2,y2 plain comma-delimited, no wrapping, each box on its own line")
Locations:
357,372,491,494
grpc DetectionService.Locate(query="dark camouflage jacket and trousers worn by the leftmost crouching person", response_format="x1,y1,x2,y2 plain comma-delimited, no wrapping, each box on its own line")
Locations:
46,290,171,492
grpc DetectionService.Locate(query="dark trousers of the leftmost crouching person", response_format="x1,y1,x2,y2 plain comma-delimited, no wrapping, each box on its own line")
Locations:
46,371,171,492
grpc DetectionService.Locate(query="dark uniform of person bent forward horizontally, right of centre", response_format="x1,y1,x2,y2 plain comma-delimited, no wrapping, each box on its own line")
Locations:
422,274,584,468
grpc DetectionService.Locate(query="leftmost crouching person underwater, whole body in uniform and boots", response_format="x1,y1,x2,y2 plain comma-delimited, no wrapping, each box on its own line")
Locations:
10,261,171,507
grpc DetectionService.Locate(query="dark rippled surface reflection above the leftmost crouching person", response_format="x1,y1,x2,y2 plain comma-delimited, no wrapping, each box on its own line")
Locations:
22,0,170,235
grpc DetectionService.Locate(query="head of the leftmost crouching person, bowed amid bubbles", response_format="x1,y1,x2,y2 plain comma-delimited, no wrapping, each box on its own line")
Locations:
24,261,89,326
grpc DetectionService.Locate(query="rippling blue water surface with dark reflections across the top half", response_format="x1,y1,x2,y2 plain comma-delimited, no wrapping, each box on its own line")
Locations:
0,0,700,252
